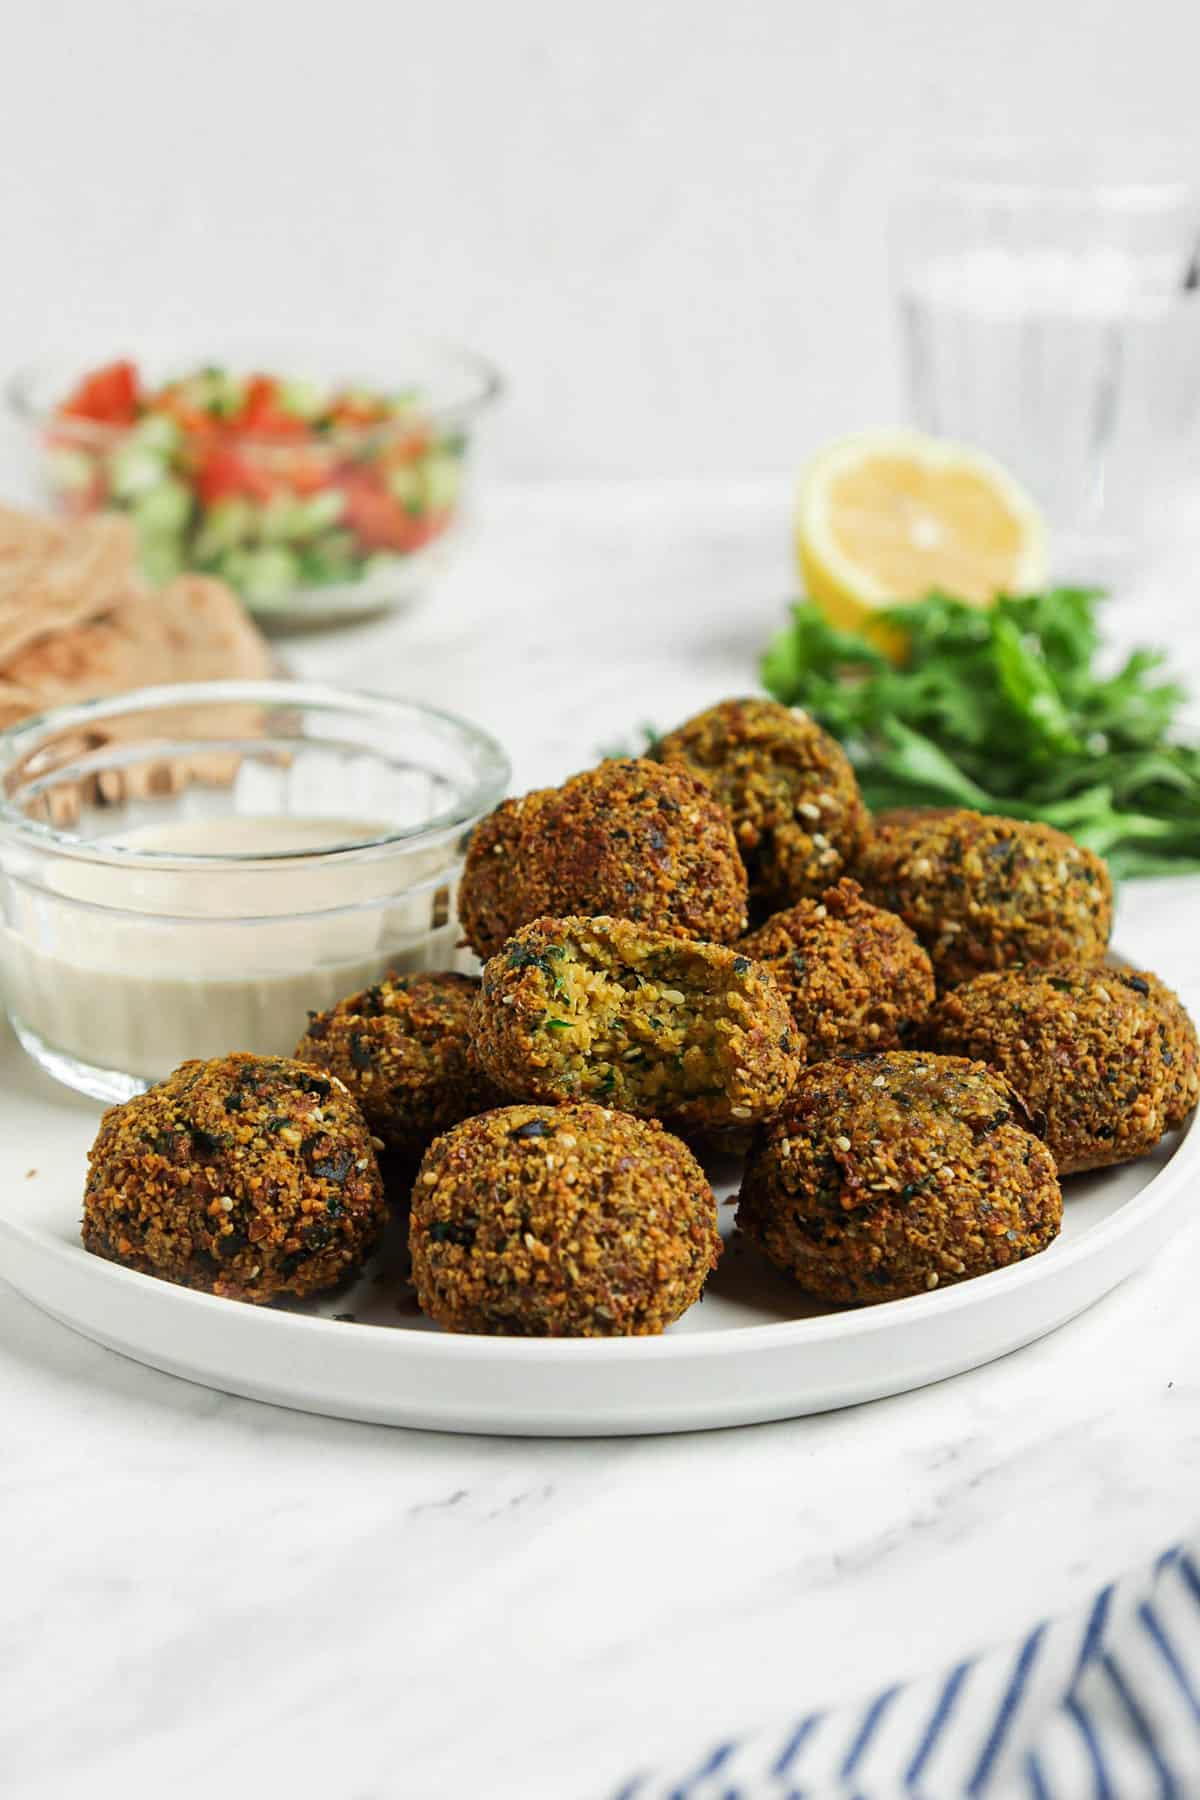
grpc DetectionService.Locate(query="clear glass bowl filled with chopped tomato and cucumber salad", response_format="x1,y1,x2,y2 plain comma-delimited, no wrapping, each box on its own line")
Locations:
7,340,500,623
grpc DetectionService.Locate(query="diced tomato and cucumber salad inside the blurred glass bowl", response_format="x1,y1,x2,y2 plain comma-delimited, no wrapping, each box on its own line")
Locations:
45,362,464,608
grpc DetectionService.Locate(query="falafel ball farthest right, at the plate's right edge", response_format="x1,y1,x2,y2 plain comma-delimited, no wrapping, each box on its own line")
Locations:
927,965,1200,1175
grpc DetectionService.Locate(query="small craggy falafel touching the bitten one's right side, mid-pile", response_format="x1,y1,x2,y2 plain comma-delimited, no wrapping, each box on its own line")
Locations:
739,880,934,1062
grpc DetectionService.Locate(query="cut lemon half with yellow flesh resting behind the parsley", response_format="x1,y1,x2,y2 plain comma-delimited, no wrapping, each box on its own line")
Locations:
795,432,1045,650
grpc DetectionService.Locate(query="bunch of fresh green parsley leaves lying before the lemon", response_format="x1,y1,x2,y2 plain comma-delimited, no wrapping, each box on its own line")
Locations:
763,589,1200,877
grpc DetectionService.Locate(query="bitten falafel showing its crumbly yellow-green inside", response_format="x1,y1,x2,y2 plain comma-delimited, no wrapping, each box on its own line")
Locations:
475,918,802,1129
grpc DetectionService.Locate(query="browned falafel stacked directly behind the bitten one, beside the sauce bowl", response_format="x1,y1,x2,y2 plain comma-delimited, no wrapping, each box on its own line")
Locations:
459,758,747,961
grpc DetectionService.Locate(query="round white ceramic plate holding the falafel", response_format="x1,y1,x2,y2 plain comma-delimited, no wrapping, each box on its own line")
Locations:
0,964,1200,1436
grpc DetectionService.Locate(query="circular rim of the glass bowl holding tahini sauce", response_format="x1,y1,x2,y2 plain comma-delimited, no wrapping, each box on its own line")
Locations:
0,680,513,873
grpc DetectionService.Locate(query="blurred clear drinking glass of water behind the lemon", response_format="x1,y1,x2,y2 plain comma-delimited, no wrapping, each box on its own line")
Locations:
892,144,1200,578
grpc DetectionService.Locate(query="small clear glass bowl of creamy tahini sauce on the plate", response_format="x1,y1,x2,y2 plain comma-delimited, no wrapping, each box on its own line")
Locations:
0,680,509,1102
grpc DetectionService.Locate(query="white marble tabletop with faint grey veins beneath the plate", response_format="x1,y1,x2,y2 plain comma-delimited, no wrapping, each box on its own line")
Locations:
0,486,1200,1800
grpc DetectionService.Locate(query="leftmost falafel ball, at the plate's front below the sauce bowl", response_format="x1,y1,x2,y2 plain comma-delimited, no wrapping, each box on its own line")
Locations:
83,1053,385,1301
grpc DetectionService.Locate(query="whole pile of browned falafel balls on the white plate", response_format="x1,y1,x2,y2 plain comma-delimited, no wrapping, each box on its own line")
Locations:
83,700,1200,1336
